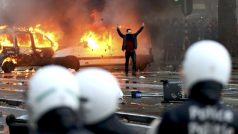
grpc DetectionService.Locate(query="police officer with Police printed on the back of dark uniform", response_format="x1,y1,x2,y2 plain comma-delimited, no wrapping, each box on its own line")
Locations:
158,40,238,134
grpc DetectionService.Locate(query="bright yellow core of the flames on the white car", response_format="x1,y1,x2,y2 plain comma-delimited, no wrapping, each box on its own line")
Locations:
80,31,113,51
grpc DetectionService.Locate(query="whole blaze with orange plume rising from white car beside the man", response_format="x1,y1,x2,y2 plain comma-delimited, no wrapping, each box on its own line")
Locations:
79,10,122,56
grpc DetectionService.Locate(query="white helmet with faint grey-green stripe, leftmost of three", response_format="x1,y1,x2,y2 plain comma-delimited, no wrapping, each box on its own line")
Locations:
27,65,79,125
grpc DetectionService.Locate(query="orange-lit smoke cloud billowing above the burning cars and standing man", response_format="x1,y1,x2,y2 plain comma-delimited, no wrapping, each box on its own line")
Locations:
0,0,183,66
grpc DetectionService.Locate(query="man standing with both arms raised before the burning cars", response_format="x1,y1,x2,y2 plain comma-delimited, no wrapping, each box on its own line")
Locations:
117,23,145,76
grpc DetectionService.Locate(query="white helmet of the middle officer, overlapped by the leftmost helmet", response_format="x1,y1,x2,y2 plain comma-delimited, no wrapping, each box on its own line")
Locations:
76,68,121,125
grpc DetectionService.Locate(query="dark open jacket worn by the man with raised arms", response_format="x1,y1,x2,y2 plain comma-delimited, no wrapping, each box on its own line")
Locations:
117,26,144,51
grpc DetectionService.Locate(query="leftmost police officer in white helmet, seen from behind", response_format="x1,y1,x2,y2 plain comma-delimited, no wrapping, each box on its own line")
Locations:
27,66,89,134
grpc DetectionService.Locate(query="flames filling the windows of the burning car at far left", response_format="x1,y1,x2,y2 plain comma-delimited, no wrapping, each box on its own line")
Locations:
0,24,59,51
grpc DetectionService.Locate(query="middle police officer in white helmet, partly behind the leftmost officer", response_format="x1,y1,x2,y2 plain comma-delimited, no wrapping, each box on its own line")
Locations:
76,68,135,134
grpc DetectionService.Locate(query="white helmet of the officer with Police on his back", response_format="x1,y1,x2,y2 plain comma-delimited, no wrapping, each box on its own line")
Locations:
183,40,231,89
